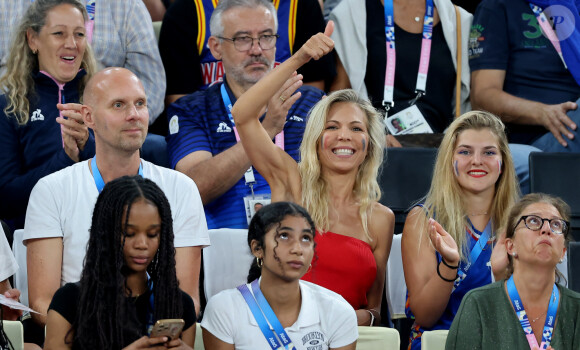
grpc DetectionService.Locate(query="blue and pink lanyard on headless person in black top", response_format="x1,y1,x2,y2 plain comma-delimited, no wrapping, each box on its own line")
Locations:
383,0,435,111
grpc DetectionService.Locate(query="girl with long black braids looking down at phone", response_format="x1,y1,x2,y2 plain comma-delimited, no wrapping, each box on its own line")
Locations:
45,176,195,349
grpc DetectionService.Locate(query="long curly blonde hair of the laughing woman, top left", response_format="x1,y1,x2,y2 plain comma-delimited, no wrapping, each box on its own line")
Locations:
0,0,97,125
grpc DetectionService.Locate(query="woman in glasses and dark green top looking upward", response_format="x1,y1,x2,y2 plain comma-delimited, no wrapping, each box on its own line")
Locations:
446,193,580,350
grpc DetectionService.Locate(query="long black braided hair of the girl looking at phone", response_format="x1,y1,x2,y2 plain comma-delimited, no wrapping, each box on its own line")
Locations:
67,176,183,349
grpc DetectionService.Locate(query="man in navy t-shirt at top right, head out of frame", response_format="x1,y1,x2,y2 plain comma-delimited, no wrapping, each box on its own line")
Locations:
468,0,580,152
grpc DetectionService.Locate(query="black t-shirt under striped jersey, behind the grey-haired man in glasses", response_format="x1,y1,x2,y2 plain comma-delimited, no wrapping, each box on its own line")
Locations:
159,0,336,95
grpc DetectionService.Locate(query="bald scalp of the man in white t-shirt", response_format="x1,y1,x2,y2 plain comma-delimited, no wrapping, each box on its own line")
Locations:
83,67,143,108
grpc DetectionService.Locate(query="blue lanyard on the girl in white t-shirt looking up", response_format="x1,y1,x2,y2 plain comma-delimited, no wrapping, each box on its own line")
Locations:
238,279,296,350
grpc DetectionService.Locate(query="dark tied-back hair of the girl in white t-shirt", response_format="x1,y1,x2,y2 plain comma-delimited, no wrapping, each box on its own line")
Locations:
248,202,316,283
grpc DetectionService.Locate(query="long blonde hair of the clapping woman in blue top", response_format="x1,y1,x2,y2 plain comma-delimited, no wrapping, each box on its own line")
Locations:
419,111,519,260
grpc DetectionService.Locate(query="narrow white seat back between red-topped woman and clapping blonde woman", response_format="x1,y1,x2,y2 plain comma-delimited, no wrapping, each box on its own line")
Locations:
385,234,407,320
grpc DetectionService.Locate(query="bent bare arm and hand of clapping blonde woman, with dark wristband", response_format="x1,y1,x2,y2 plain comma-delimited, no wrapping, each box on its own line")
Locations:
401,207,459,327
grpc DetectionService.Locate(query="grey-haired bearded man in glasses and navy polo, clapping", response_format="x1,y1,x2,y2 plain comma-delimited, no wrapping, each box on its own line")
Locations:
167,0,324,229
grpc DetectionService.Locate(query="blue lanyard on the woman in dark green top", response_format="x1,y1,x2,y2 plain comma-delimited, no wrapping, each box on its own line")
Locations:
506,275,560,350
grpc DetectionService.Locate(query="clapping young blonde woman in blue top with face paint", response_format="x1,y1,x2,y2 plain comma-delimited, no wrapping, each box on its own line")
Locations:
401,111,518,349
